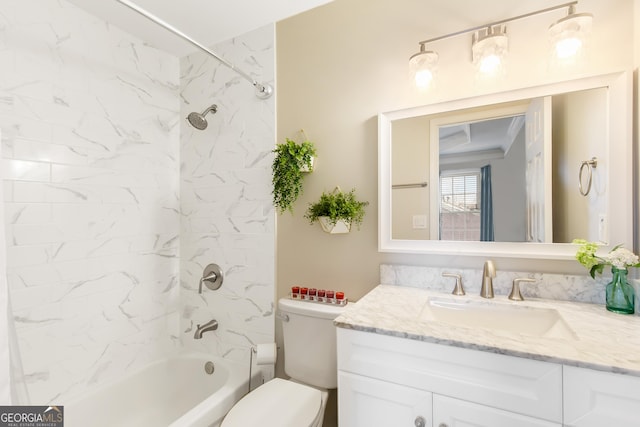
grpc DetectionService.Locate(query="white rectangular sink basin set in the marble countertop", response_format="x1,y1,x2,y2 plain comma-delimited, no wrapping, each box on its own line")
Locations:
420,297,577,340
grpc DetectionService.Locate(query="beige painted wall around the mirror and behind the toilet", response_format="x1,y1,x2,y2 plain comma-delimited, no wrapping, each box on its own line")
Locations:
276,0,638,308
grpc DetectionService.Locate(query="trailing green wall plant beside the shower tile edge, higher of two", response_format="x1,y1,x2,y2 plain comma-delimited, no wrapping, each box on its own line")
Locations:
271,138,316,213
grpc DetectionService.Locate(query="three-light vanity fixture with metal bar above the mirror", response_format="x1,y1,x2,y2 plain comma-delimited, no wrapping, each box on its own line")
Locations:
409,1,593,89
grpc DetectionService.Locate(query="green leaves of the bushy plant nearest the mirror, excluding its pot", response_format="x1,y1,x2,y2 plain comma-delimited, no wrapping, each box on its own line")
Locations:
305,188,369,228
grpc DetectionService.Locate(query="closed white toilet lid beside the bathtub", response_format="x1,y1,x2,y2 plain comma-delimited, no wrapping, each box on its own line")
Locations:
222,378,322,427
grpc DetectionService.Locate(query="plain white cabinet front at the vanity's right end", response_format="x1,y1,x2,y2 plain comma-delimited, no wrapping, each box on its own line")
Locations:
563,366,640,427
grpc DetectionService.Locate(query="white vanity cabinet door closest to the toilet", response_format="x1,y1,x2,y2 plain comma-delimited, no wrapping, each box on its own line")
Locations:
338,371,432,427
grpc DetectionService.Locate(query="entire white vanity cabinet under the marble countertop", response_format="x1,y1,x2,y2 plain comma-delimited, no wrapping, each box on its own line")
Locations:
337,328,640,427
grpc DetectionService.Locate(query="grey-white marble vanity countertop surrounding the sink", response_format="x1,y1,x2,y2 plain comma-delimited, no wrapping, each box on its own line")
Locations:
334,285,640,376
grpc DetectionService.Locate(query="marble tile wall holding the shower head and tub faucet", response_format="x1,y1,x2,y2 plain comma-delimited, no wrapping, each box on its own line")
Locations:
180,25,275,362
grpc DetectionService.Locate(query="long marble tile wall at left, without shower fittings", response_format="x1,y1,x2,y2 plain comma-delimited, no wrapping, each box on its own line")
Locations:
0,0,180,404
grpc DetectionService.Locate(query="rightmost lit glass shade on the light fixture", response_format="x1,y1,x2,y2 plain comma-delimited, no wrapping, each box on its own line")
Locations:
549,13,593,60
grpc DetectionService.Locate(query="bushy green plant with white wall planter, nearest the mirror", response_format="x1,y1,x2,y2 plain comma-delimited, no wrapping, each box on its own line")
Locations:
305,187,369,234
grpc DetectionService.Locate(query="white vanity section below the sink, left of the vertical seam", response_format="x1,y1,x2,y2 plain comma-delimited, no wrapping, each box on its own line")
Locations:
338,328,562,427
